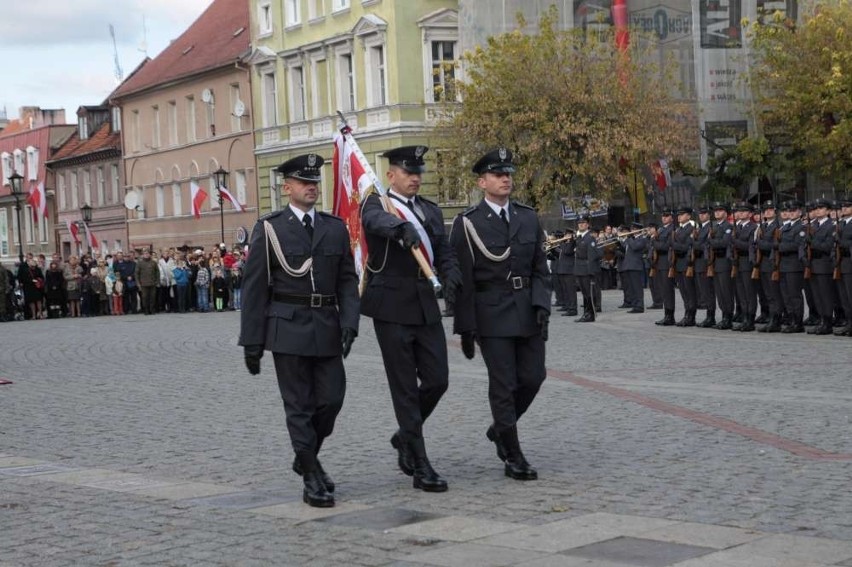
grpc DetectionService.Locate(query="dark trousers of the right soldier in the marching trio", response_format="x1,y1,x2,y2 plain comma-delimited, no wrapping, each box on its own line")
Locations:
479,336,544,432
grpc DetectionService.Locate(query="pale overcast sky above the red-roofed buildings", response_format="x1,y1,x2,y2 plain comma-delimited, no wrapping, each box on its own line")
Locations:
0,0,212,123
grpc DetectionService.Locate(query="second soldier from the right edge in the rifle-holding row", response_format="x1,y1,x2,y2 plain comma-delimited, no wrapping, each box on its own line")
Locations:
808,199,834,335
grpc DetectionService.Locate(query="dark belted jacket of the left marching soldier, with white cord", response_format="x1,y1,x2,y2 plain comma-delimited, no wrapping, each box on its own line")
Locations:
239,207,359,357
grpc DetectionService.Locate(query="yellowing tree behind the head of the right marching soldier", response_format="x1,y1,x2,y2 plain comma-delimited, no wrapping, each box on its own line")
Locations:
439,8,698,210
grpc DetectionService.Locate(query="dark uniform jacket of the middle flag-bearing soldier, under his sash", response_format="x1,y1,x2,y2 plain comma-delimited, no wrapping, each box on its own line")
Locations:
361,194,458,325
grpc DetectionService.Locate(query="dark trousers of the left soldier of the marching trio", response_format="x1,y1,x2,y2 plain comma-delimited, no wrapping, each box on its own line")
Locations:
272,353,346,454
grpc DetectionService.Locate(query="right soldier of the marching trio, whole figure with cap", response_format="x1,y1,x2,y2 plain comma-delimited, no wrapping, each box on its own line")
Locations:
452,148,550,480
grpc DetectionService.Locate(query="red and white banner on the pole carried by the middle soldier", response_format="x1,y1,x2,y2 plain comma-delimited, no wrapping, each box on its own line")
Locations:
332,133,373,278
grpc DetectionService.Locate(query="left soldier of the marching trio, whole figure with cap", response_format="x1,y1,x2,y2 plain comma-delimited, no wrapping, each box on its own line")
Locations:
239,154,359,507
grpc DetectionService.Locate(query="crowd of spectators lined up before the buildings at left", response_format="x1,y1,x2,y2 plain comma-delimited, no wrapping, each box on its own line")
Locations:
0,245,244,321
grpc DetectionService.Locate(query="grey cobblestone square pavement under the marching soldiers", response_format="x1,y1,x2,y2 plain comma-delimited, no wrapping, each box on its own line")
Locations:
0,291,852,567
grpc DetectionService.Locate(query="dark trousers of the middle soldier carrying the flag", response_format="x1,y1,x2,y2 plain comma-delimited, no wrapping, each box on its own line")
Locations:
373,319,450,440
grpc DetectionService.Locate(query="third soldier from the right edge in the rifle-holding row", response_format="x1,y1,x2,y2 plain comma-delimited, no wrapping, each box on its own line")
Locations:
777,201,806,333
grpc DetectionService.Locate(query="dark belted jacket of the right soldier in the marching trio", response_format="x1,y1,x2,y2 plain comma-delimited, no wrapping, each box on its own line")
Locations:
451,200,551,337
